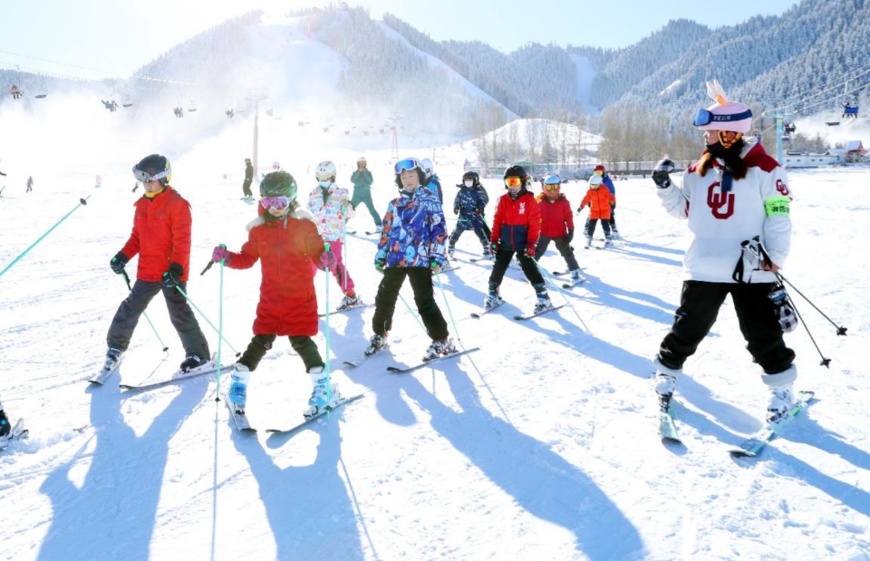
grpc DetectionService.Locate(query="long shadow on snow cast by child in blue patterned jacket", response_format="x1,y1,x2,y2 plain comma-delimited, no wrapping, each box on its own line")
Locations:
402,367,644,560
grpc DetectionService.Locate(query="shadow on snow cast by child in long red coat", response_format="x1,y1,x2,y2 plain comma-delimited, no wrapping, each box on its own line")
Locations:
233,415,365,561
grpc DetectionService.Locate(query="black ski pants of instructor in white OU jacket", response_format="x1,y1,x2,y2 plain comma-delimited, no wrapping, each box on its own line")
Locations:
659,281,795,374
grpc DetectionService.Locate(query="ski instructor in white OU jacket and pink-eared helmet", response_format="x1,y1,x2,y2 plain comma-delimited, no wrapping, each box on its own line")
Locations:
653,81,797,421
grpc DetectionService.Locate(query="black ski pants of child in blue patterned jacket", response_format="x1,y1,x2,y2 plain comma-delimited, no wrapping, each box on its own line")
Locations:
372,267,450,340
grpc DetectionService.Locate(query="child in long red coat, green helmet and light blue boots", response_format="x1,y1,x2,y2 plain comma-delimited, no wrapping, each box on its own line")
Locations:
212,171,341,417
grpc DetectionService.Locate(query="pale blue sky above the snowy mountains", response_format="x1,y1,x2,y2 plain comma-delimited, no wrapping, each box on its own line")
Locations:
0,0,799,78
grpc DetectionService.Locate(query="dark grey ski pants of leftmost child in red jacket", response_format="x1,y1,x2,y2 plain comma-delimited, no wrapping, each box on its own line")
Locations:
106,280,211,358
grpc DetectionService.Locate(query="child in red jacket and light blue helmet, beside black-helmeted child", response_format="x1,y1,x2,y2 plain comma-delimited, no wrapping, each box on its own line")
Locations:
535,174,583,282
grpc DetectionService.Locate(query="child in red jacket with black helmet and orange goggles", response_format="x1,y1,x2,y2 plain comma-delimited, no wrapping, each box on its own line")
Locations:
483,166,553,313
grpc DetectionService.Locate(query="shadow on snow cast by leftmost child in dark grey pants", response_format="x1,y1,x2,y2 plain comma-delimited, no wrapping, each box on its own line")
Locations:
38,380,208,561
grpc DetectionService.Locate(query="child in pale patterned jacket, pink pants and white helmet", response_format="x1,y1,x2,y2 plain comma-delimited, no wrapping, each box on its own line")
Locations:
308,161,361,310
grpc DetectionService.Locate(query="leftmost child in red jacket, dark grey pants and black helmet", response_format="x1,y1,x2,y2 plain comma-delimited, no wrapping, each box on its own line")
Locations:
104,154,210,371
